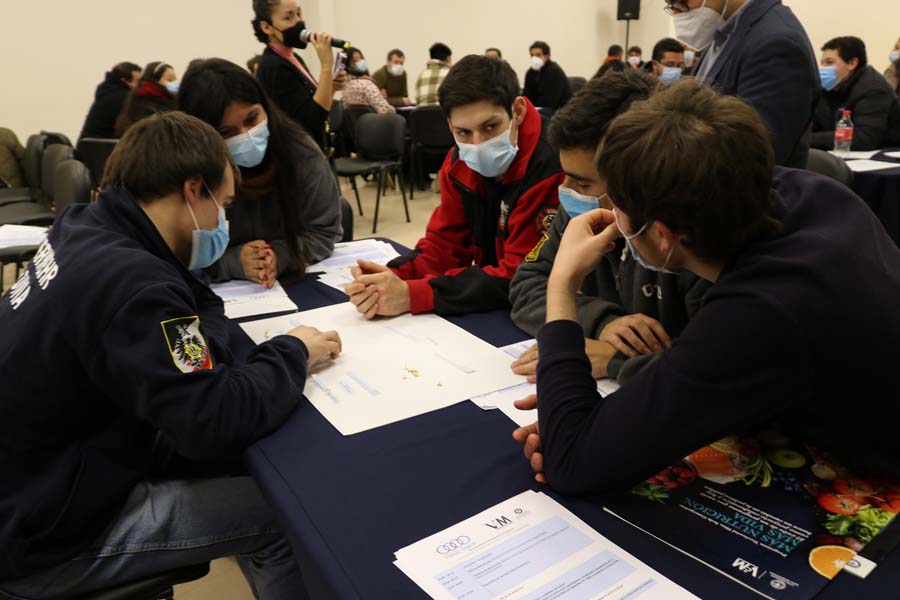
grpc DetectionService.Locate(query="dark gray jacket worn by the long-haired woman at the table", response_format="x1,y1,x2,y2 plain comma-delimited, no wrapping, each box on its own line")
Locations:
208,143,343,283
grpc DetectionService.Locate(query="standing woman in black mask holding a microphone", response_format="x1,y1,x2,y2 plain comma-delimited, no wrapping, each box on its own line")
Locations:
252,0,346,148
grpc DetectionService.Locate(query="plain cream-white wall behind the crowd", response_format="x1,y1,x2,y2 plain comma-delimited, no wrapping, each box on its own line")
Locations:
0,0,900,140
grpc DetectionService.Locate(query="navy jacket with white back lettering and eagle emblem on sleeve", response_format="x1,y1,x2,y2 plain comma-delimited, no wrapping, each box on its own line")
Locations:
0,192,307,580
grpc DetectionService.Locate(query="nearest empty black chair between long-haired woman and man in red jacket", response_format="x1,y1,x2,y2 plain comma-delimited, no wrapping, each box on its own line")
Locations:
335,114,410,234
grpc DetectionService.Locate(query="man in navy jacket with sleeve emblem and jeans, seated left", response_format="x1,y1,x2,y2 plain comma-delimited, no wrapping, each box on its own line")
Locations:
0,110,341,600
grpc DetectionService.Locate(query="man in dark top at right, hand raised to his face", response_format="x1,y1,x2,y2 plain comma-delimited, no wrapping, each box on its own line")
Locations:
514,79,900,493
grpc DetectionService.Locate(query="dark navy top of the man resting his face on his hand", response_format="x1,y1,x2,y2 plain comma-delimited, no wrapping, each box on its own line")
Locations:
537,169,900,493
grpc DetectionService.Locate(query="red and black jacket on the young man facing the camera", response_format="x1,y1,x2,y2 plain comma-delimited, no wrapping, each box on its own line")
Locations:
390,100,565,314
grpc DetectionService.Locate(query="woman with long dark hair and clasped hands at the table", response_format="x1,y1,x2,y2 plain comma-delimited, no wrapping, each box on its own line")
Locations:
178,58,343,287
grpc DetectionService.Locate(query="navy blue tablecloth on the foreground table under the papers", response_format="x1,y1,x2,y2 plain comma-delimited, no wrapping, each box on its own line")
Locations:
235,241,900,600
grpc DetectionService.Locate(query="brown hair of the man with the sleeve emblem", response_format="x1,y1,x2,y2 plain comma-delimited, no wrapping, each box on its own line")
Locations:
100,111,241,202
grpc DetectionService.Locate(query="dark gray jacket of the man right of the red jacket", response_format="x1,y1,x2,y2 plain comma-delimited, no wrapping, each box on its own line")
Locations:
509,206,711,383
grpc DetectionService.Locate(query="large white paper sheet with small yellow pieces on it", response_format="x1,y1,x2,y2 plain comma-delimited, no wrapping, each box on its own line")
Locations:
241,302,522,435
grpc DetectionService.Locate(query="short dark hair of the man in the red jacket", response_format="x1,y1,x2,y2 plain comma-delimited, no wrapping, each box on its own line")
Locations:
438,54,520,118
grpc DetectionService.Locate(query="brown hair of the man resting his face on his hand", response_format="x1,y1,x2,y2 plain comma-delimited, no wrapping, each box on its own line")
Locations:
596,78,778,261
